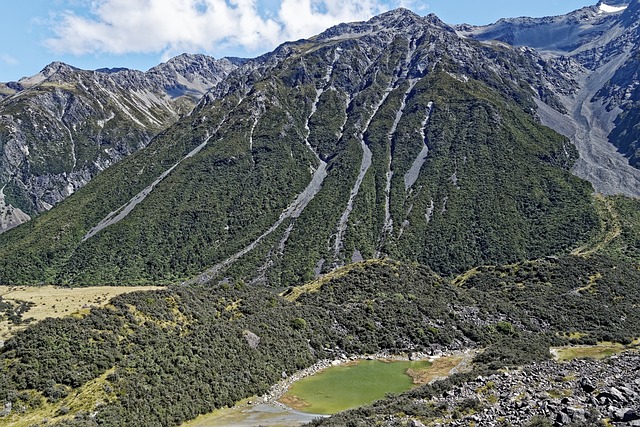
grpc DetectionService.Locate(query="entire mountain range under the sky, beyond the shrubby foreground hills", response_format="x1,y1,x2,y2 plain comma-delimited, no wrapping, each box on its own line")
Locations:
0,1,640,285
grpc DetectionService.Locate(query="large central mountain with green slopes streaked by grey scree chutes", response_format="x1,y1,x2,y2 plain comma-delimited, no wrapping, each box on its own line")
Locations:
0,9,598,286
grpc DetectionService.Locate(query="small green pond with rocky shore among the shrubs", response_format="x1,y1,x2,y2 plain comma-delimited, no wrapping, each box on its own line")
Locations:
280,360,431,414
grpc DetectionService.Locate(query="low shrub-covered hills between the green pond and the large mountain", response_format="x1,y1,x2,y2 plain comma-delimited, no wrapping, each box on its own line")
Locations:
0,256,640,426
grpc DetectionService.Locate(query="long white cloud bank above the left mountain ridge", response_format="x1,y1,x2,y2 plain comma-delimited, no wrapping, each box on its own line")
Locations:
45,0,385,56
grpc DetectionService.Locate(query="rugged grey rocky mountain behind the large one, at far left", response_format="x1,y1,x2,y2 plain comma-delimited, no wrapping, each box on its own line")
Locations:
0,54,243,232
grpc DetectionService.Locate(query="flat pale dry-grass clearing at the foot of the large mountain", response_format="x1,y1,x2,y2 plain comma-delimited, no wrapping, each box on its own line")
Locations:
0,286,164,341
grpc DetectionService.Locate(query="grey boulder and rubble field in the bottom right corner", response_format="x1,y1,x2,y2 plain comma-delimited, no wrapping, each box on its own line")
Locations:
418,352,640,426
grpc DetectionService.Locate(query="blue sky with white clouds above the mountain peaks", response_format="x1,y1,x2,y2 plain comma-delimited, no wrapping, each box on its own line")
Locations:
0,0,597,82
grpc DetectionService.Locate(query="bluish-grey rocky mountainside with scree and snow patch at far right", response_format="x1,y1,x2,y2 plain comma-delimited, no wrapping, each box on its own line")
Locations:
457,0,640,197
